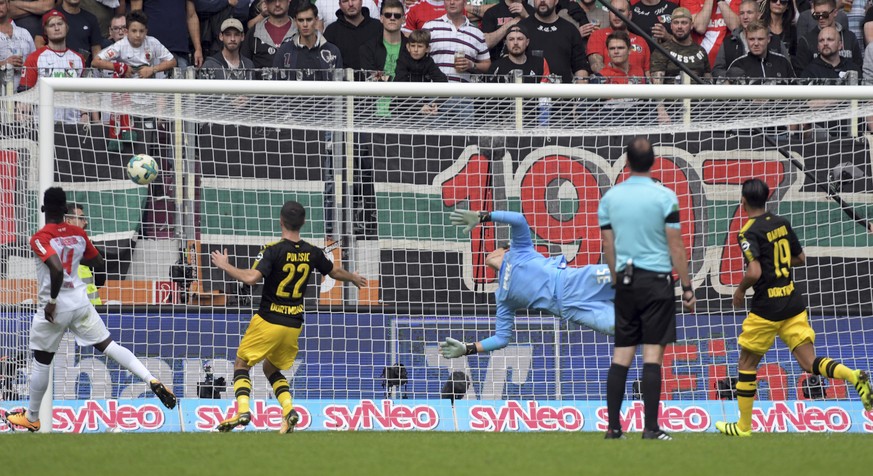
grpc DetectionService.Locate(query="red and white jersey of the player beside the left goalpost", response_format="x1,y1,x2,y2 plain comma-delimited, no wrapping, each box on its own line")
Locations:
30,223,99,311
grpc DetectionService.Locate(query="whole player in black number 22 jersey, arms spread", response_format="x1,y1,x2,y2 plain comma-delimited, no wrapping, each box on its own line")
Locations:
212,201,367,433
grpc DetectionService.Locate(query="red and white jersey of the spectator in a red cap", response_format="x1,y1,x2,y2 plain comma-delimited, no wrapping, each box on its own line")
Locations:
19,46,85,124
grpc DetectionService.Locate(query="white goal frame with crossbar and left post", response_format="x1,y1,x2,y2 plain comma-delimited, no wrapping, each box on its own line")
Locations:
30,77,873,432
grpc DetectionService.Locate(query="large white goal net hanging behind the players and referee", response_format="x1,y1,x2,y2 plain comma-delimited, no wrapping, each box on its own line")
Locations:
0,78,873,431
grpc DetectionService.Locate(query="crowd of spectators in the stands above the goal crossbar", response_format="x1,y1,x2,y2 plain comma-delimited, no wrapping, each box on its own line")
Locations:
0,0,873,118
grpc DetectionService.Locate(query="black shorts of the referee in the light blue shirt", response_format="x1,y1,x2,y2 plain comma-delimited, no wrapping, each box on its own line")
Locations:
615,268,676,347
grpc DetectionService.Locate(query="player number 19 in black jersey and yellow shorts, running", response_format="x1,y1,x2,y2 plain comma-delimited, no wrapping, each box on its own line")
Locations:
715,179,873,436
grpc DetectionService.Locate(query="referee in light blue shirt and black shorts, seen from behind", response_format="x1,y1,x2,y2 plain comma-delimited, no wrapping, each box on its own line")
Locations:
597,137,696,440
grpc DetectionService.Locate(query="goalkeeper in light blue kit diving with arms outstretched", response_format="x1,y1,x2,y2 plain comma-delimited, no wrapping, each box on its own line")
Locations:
439,210,615,359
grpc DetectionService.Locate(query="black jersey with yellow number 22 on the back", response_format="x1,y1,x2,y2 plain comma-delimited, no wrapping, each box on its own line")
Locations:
252,239,333,327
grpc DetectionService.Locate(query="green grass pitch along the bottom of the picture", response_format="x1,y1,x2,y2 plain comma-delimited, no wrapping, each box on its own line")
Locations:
0,431,873,476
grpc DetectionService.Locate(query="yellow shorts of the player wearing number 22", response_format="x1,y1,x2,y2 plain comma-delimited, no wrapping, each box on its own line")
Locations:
236,314,303,370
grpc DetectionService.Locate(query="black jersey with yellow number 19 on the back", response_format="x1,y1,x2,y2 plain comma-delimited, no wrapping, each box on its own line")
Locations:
737,212,806,321
